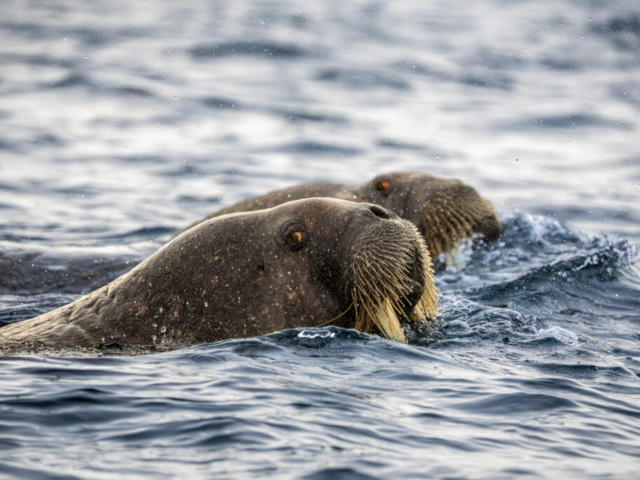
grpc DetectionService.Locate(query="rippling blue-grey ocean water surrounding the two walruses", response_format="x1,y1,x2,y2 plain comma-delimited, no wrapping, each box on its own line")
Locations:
0,0,640,480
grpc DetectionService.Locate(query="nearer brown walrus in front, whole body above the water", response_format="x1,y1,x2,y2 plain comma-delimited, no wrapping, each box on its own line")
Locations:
0,198,437,348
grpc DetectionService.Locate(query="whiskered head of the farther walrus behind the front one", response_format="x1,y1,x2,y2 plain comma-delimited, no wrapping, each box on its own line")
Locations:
358,172,501,257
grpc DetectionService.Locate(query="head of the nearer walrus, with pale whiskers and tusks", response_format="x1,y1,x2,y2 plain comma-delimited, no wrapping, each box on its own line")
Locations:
239,198,437,342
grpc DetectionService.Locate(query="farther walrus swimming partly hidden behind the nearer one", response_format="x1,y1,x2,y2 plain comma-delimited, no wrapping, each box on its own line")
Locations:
189,172,501,258
